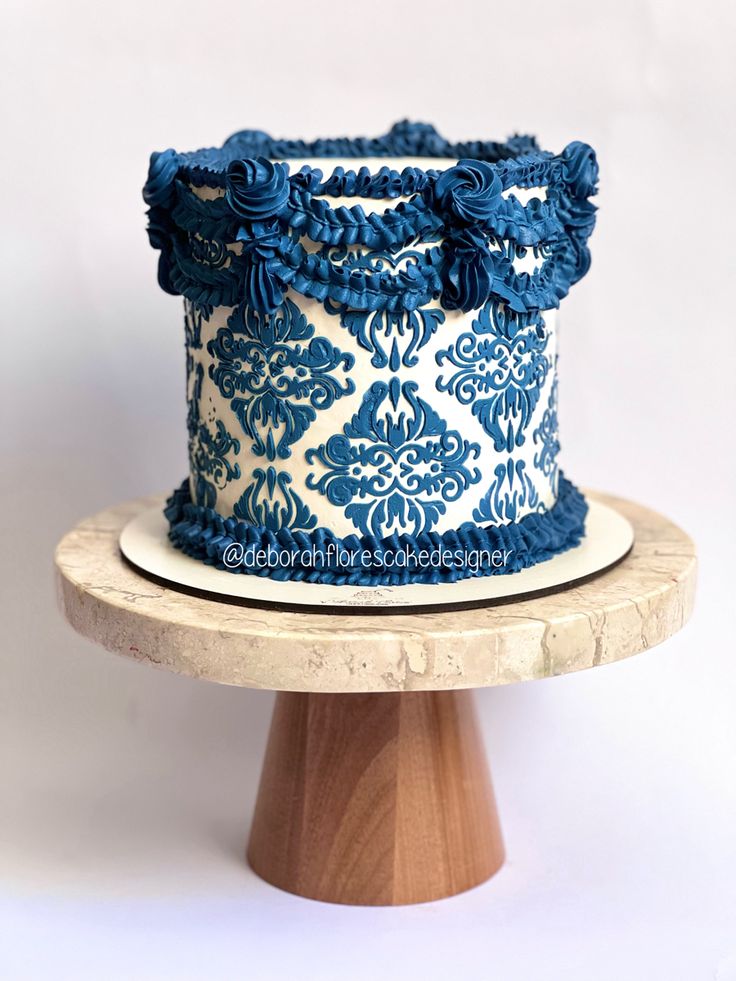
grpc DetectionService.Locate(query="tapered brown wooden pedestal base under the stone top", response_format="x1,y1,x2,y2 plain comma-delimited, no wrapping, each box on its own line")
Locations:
248,691,504,906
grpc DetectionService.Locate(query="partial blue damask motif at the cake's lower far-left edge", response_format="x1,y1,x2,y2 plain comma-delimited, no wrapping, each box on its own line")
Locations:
187,362,240,508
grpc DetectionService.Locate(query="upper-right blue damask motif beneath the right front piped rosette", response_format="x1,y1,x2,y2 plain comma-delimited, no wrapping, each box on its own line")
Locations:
436,300,552,452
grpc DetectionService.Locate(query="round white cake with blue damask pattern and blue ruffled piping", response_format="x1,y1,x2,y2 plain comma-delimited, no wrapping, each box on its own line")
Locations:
143,122,598,585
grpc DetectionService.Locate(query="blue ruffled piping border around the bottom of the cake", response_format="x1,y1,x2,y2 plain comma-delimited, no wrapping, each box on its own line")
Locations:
164,475,588,586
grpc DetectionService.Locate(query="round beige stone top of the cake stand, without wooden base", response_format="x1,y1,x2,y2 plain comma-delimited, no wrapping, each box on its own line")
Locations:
56,493,696,692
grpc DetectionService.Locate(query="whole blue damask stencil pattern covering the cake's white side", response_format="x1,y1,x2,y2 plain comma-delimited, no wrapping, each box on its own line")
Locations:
186,288,559,538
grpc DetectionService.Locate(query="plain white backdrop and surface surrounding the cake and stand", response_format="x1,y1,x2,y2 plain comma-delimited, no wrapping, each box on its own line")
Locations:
0,0,736,981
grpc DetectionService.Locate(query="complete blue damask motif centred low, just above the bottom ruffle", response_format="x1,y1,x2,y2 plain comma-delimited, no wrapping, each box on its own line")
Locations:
306,378,481,538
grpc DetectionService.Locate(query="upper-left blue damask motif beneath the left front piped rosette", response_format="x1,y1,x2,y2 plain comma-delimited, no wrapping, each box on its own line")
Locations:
207,299,355,460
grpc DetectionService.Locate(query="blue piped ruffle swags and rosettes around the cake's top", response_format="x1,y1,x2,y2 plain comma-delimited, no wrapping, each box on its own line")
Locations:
143,122,598,313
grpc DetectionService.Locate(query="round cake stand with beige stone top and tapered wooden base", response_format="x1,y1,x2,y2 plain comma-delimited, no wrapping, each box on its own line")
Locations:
56,493,696,905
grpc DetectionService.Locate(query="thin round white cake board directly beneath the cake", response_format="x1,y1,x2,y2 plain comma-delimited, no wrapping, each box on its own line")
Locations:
120,501,634,613
